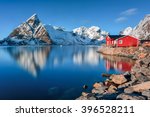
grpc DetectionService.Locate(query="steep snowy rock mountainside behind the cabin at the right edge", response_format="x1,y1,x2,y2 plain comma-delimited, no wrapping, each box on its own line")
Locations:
130,14,150,40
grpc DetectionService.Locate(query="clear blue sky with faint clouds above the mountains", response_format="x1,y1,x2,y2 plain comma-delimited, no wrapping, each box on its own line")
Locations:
0,0,150,38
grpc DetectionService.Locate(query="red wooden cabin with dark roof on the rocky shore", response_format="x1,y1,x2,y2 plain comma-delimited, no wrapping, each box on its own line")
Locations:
106,35,139,47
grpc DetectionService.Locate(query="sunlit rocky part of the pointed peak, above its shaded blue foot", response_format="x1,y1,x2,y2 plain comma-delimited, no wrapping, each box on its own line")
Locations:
7,14,51,44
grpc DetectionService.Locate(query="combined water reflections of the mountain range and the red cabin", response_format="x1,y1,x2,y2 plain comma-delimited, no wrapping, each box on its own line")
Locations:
3,46,134,77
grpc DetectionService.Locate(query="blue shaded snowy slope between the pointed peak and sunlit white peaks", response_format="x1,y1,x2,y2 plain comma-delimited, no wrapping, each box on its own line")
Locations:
45,25,102,45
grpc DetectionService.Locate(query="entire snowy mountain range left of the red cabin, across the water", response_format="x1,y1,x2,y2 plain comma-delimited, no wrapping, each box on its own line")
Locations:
0,14,107,45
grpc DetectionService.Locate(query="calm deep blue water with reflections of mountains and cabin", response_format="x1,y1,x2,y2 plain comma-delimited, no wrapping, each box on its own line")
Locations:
0,46,134,100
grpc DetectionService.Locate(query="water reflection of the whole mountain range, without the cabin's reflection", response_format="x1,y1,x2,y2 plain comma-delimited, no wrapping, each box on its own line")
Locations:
3,46,99,77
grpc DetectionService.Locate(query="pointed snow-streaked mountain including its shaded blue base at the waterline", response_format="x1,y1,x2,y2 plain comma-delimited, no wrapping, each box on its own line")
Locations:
5,14,51,45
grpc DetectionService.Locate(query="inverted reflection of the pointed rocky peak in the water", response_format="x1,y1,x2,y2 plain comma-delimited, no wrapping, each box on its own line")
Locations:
7,47,50,77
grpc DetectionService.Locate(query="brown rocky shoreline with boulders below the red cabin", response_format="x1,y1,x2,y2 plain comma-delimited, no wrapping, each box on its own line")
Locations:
77,47,150,100
